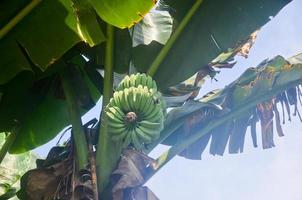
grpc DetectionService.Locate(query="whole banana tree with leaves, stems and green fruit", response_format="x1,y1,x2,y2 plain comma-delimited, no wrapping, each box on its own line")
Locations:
0,0,302,200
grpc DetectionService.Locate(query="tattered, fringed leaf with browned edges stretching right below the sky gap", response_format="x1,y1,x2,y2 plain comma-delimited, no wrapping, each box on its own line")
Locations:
151,54,302,159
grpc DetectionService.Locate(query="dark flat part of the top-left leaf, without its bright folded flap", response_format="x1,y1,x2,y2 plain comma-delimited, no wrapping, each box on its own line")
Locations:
0,0,81,84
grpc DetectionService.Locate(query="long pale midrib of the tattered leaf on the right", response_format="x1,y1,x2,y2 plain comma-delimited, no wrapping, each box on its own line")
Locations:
146,79,302,181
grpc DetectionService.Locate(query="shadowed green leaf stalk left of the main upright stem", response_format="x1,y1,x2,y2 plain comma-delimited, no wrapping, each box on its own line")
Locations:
60,67,88,169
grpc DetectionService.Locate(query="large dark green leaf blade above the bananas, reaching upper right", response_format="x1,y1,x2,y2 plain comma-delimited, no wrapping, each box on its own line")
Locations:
133,0,289,88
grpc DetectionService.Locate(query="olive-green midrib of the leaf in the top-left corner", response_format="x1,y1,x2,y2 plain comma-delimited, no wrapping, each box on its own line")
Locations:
0,0,42,40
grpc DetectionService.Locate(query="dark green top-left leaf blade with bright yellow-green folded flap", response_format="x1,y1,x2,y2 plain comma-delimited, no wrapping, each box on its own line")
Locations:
0,0,105,85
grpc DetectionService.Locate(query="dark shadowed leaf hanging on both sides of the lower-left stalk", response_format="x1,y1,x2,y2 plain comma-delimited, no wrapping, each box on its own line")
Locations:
0,59,100,153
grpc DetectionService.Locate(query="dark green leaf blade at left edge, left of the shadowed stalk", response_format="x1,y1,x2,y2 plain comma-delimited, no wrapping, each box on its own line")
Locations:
0,73,69,153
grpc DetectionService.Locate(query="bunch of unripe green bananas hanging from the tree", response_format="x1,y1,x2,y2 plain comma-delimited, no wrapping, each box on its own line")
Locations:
105,74,165,149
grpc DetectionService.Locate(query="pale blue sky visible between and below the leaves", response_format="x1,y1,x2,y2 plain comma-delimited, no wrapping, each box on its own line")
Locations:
35,0,302,200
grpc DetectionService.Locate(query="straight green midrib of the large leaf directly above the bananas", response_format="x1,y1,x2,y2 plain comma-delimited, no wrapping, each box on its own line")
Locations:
147,0,203,76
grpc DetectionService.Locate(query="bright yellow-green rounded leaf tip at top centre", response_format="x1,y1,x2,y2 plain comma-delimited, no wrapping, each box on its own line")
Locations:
89,0,156,28
